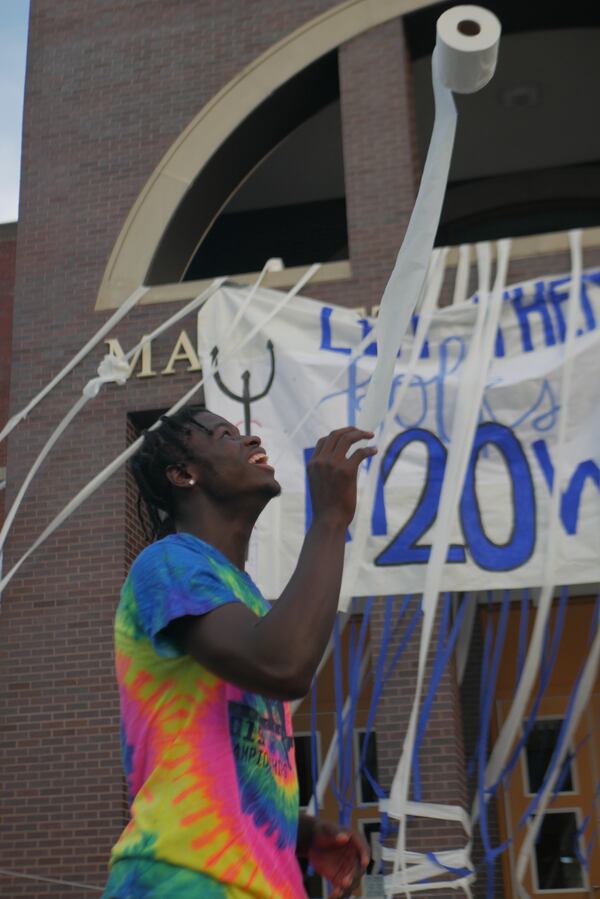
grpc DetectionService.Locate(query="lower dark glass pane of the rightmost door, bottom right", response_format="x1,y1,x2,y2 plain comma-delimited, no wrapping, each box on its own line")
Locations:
535,812,583,890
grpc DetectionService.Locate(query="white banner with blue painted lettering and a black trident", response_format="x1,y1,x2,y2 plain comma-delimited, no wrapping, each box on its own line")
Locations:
198,271,600,597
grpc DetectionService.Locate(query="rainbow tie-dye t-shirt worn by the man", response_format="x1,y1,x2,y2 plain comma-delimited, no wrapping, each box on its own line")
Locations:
105,534,306,899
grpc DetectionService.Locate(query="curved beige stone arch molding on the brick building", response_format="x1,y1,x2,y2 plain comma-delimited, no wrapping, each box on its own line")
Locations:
96,0,433,310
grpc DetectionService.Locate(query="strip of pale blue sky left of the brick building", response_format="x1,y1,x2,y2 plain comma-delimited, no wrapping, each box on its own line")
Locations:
0,0,29,223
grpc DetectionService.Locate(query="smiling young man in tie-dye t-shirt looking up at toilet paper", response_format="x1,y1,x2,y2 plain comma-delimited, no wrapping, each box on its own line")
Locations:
104,407,375,899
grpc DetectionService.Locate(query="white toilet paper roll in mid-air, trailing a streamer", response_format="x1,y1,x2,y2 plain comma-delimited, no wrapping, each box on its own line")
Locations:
436,6,501,94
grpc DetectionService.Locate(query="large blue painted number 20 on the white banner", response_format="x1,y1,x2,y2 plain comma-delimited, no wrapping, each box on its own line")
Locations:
372,422,535,571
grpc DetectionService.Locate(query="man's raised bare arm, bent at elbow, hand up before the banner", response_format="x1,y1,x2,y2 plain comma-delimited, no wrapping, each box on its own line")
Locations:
171,428,376,700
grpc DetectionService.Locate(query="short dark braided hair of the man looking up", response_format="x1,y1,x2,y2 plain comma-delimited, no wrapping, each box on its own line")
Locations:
130,405,208,542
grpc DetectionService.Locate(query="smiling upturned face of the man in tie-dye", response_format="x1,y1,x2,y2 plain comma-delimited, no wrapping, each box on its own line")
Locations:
186,411,281,499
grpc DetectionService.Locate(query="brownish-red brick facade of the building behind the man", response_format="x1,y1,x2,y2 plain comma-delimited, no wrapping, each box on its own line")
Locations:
0,0,591,899
